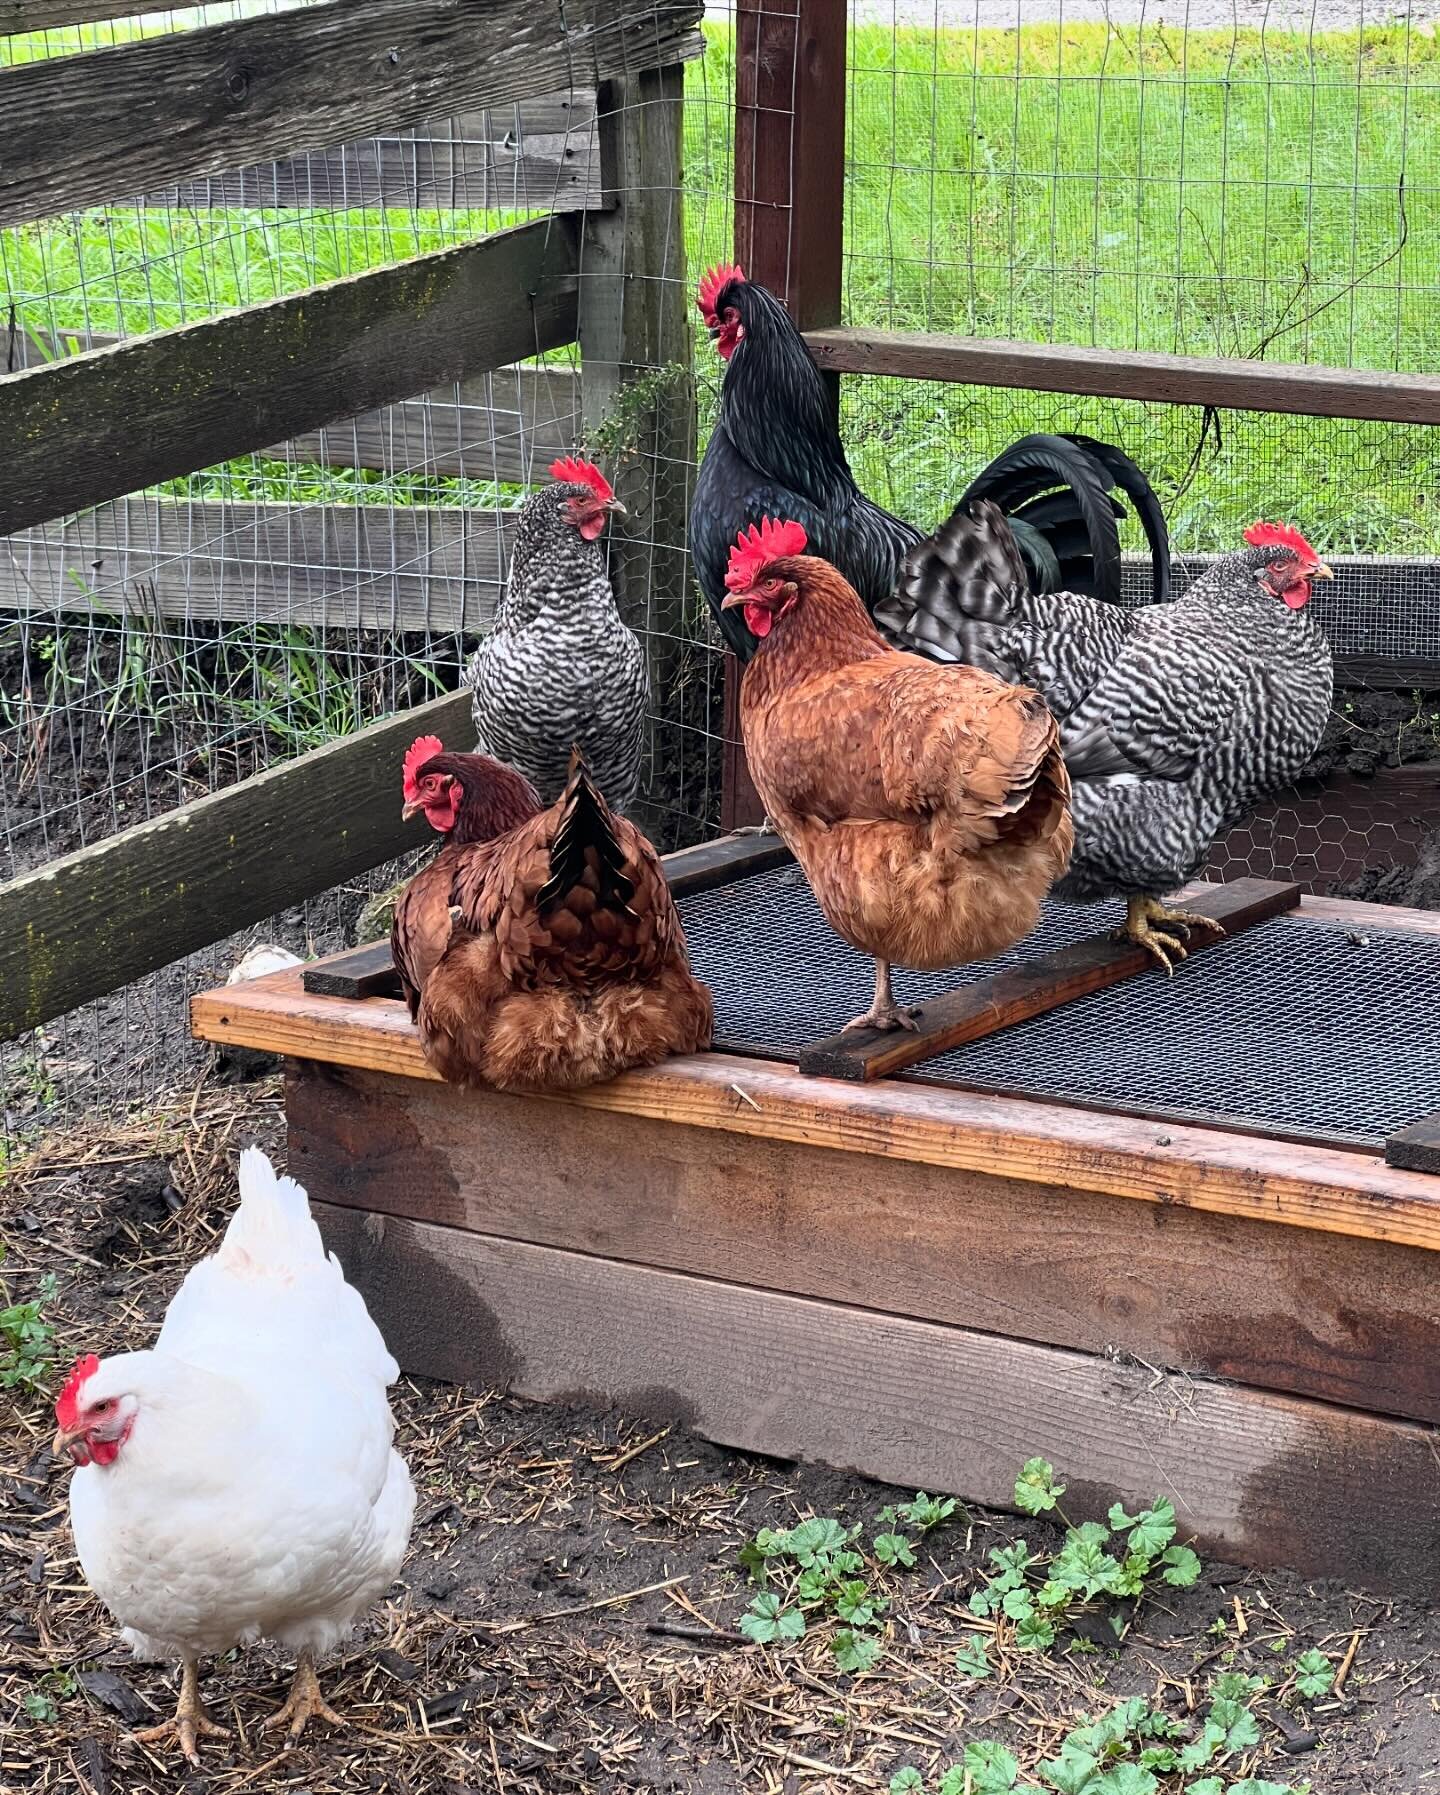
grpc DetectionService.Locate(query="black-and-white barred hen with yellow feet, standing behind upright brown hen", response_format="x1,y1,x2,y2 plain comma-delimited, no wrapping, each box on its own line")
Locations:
896,503,1334,969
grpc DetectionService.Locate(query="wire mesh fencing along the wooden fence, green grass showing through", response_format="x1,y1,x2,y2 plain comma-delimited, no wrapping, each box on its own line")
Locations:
0,0,1440,1131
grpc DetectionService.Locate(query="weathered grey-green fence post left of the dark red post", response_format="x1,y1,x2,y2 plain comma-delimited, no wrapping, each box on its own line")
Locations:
580,66,695,833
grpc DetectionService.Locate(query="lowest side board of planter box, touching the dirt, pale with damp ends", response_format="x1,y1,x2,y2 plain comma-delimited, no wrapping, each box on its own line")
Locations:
318,1204,1440,1594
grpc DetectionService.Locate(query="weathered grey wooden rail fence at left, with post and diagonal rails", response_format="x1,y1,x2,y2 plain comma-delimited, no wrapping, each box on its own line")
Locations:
0,0,700,1038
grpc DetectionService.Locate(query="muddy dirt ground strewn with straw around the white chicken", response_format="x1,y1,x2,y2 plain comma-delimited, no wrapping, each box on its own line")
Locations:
0,1086,1440,1795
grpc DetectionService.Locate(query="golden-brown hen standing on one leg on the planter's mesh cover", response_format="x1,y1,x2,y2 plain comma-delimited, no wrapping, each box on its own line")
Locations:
725,521,1070,1029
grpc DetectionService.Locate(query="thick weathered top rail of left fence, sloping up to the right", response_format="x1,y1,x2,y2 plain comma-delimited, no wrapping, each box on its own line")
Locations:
0,0,700,226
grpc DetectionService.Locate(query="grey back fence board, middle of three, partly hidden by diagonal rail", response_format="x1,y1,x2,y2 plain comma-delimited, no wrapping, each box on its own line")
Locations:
0,330,580,485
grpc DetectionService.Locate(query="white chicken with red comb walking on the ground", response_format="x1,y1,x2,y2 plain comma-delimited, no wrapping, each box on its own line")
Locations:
54,1147,415,1763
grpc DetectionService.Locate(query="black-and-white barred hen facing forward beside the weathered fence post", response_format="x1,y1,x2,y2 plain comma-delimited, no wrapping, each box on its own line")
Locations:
470,460,650,813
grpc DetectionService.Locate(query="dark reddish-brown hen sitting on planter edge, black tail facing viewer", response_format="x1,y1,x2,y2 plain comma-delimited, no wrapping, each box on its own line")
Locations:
391,738,715,1091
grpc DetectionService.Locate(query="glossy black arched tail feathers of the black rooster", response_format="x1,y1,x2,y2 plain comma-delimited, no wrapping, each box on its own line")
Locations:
961,434,1171,603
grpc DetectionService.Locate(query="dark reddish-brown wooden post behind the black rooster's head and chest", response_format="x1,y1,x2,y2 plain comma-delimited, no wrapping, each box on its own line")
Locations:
722,0,846,829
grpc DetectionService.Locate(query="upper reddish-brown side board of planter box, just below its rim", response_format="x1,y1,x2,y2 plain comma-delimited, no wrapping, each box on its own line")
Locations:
285,1064,1440,1422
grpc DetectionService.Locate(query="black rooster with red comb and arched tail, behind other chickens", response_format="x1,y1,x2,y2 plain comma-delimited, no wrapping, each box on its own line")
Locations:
689,267,1171,661
